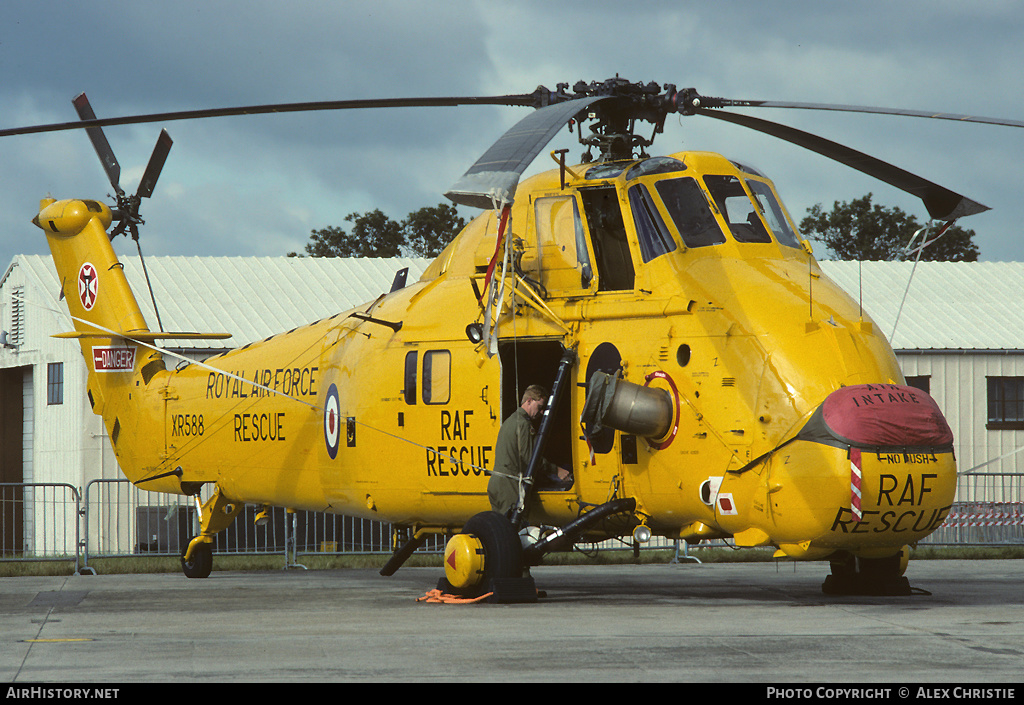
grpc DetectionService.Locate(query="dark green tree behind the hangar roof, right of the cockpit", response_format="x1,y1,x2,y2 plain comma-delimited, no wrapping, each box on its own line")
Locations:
800,194,979,262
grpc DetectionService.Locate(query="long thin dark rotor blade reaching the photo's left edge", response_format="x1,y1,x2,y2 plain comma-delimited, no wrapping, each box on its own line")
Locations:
0,93,537,141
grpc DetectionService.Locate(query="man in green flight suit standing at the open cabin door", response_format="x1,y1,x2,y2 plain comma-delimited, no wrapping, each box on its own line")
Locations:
487,384,572,516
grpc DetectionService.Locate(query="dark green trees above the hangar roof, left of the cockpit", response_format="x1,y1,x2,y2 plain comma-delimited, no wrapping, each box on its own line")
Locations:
289,203,466,257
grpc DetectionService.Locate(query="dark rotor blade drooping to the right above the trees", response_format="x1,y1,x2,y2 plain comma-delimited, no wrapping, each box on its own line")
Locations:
696,108,989,220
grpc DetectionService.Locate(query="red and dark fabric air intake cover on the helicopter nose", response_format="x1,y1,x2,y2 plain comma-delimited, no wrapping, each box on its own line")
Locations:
797,384,953,448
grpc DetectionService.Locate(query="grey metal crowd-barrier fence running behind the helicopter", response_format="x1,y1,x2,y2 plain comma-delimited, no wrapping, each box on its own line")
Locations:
0,473,1024,572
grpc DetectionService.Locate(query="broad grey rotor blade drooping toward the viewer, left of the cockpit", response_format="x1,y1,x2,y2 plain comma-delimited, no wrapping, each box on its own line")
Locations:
444,95,611,209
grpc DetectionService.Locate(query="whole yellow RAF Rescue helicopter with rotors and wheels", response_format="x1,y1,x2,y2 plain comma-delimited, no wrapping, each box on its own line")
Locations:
6,78,1024,602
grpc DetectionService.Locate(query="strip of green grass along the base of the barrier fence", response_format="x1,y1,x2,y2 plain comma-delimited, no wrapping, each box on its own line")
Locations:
0,546,1024,578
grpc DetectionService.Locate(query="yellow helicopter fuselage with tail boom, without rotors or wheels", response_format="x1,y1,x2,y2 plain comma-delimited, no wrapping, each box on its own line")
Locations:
39,153,956,559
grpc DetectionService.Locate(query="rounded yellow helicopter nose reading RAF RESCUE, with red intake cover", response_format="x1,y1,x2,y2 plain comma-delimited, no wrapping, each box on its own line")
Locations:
772,384,956,557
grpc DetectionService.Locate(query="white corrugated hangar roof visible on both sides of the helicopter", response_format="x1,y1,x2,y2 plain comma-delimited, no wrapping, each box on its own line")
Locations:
4,255,1024,350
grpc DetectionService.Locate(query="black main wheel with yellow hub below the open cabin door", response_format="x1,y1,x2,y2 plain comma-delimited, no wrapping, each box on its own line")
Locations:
442,511,522,596
